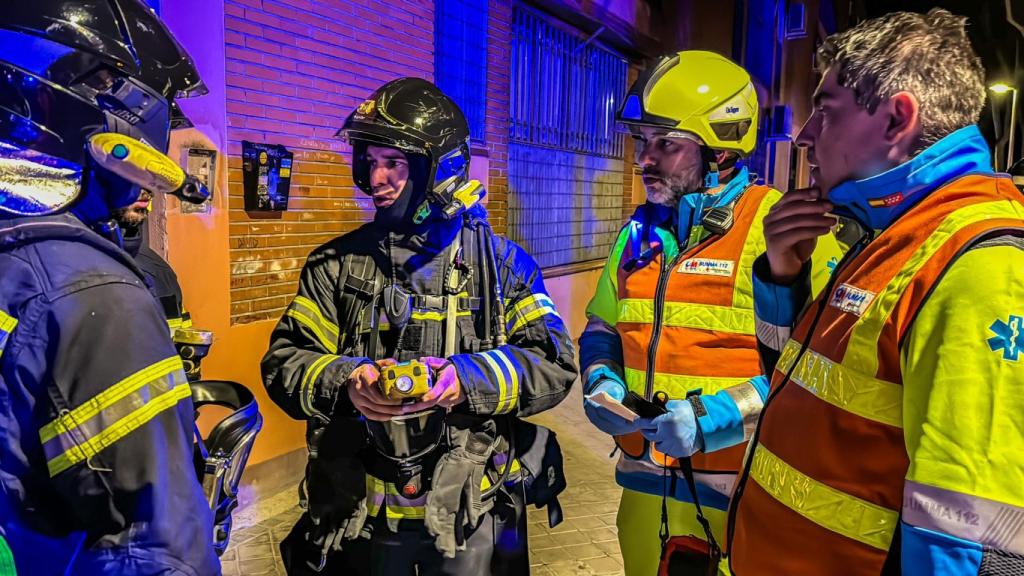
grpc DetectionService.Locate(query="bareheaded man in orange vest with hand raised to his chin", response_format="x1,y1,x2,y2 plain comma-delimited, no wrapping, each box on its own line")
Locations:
729,9,1024,576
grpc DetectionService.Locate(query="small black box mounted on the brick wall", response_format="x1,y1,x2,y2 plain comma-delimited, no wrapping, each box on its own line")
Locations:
242,140,292,212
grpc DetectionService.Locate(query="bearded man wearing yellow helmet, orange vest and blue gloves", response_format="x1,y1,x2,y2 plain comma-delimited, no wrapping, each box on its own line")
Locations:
580,50,839,575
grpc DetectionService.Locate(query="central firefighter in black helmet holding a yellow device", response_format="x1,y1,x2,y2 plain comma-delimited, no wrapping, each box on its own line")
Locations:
263,78,577,575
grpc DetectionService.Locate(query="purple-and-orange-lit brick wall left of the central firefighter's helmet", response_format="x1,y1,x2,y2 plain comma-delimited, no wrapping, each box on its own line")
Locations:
224,0,436,323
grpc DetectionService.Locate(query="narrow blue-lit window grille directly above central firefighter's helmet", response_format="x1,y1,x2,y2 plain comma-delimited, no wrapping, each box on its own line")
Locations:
434,0,487,142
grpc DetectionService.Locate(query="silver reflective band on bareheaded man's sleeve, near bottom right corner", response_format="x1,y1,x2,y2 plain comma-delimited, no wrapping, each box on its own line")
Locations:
903,480,1024,554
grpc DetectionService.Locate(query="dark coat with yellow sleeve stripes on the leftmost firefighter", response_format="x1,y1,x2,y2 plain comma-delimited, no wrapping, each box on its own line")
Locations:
0,214,220,576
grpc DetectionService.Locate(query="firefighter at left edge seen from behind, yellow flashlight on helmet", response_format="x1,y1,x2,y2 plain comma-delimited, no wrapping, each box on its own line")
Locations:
0,0,220,576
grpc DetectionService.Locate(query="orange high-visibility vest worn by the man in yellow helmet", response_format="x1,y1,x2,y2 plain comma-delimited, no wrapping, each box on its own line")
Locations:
616,186,779,487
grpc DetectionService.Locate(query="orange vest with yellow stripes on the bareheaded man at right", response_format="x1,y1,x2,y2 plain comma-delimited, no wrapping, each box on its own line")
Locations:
730,175,1024,576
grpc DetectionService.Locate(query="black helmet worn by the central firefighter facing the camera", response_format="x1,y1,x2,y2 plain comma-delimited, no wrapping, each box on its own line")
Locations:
337,78,470,216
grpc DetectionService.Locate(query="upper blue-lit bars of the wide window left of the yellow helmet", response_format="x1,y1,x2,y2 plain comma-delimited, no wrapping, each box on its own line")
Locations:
510,7,628,158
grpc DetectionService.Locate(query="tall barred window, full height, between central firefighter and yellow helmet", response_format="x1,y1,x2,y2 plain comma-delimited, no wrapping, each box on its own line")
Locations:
508,6,631,268
